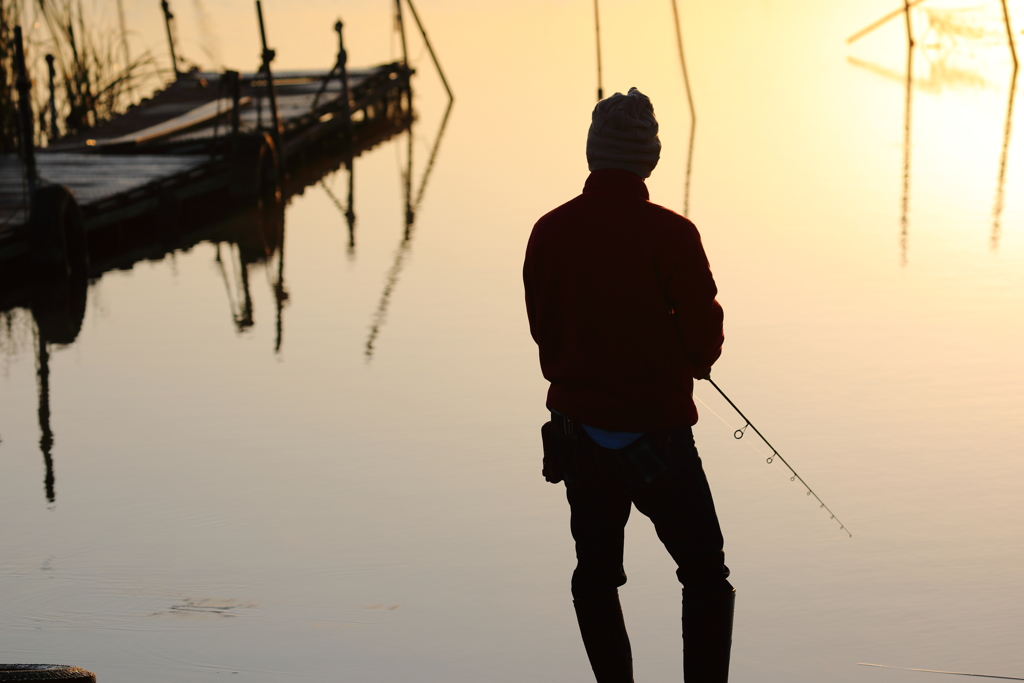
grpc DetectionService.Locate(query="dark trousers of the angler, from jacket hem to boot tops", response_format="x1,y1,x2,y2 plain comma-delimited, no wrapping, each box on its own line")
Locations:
552,416,729,599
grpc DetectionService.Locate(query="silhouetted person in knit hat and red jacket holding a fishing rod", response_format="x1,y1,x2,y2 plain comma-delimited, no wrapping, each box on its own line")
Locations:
523,88,735,683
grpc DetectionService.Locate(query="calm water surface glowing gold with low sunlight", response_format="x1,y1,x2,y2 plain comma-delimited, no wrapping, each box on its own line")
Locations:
0,0,1024,683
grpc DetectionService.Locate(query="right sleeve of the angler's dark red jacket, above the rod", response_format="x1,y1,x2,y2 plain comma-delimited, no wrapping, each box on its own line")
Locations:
668,224,725,377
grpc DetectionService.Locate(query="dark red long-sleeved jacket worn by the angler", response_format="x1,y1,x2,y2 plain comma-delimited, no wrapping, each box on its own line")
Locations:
523,169,724,432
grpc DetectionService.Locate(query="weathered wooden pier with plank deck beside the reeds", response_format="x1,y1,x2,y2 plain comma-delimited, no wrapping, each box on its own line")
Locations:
0,62,413,267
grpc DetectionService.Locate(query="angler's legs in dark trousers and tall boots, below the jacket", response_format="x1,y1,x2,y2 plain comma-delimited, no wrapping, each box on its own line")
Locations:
542,413,735,683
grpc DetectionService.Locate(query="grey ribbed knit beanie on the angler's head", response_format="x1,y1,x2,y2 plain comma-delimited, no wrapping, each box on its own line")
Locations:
587,88,662,178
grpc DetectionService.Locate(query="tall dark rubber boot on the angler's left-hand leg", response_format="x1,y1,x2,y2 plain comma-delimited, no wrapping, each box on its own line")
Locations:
572,590,633,683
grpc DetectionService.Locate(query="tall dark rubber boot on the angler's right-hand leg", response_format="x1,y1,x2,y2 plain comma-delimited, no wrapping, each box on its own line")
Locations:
683,582,736,683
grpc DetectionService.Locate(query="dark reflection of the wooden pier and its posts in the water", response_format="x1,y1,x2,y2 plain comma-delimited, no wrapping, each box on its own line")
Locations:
0,108,411,504
